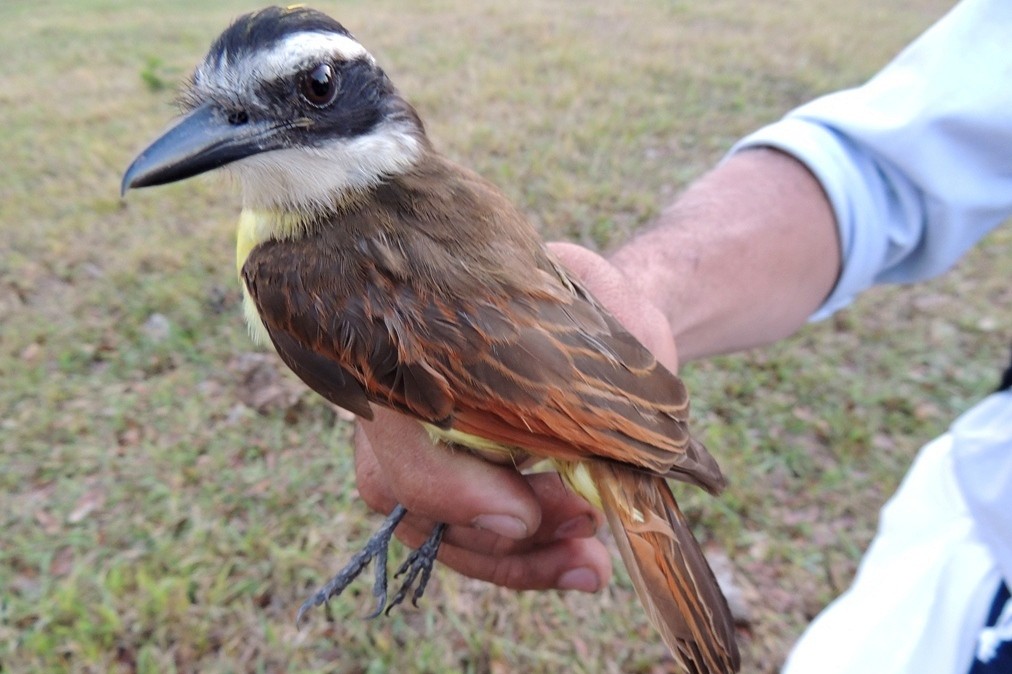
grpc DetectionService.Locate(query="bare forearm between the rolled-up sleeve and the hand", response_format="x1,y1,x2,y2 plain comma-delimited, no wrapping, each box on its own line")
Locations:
611,149,840,360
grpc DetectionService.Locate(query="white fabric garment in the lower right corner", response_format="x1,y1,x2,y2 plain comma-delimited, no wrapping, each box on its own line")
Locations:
783,392,1012,674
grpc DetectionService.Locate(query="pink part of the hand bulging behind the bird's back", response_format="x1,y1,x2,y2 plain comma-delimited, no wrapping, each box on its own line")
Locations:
549,241,678,372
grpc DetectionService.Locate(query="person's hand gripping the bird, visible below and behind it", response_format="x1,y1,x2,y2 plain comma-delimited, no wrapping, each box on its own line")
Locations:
355,243,677,592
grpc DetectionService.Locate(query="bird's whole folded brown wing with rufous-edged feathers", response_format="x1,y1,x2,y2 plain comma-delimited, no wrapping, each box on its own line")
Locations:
244,237,724,491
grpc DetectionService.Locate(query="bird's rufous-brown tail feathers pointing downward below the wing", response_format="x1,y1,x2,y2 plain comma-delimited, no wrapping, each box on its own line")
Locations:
590,461,741,674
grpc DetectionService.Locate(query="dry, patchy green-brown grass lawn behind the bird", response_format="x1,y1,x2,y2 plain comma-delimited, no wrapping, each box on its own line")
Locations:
0,0,1012,674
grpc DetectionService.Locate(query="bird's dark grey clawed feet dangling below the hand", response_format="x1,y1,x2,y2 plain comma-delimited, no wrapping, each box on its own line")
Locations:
296,505,446,626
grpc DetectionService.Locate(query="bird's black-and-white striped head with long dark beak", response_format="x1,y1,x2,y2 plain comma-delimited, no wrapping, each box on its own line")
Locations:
122,7,427,212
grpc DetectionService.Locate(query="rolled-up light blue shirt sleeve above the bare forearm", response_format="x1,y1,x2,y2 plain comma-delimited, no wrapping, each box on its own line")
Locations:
732,0,1012,319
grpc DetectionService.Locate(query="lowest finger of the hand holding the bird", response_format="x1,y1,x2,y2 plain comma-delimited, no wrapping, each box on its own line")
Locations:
402,530,612,592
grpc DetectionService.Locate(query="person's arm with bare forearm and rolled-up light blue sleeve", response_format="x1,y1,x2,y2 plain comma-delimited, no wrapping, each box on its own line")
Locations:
611,0,1012,360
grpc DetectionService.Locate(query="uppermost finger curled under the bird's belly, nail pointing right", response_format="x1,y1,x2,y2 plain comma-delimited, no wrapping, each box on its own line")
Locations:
355,409,541,539
